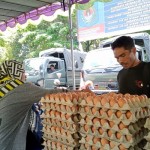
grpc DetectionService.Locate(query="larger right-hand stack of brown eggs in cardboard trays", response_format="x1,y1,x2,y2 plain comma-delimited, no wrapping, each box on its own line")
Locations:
79,93,150,150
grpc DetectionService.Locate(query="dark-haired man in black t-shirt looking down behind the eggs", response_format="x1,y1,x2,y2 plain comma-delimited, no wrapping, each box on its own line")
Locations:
111,36,150,97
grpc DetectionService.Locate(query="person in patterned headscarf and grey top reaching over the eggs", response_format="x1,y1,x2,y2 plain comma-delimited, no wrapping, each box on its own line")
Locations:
0,60,66,150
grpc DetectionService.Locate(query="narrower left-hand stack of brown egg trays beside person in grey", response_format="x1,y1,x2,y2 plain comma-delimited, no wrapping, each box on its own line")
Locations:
41,93,80,149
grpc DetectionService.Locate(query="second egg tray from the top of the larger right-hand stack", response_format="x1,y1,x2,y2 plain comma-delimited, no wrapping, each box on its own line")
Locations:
79,106,150,125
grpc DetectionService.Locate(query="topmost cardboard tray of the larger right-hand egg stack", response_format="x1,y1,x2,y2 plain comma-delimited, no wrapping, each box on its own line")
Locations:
80,96,150,110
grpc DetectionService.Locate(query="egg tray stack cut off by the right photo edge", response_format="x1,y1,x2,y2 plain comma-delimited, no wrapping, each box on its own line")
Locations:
144,117,150,150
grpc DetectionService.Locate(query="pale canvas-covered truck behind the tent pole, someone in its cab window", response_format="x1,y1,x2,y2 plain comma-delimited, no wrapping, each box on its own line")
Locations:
24,48,86,89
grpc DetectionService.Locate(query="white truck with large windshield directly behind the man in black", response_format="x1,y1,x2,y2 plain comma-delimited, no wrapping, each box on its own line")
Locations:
80,46,147,92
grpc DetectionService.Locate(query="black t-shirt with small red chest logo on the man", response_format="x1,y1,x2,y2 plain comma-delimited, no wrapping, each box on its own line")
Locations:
117,62,150,97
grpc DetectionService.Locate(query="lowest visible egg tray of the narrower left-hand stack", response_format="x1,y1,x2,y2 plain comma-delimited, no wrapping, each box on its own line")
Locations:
42,139,79,150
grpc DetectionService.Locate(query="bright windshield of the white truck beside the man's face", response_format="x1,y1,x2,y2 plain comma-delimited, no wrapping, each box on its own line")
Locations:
83,49,120,70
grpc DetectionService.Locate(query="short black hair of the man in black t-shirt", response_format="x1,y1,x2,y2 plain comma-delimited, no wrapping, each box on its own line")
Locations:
111,36,135,51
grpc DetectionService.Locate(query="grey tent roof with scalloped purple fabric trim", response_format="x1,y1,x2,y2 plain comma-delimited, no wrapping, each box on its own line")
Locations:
0,0,89,31
